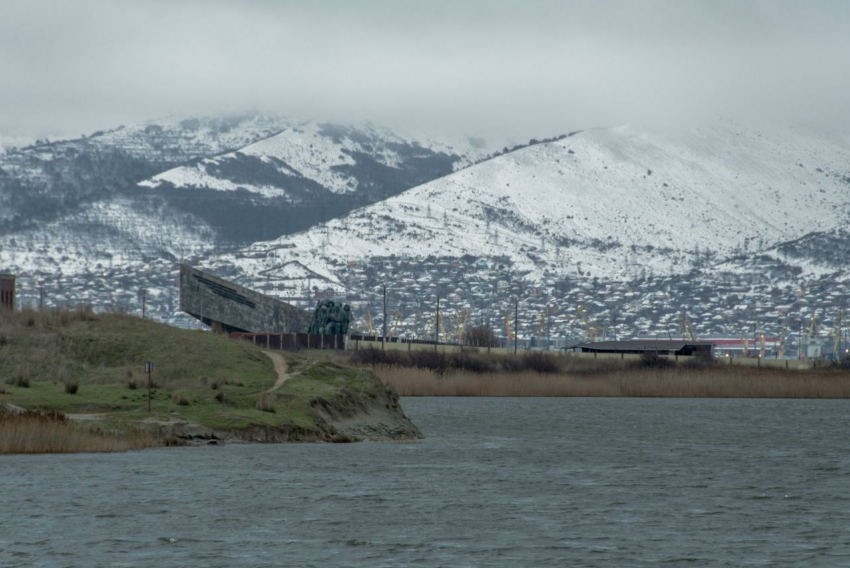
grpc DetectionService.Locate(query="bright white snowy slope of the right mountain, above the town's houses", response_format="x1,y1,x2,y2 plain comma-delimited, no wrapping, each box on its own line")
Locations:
210,122,850,287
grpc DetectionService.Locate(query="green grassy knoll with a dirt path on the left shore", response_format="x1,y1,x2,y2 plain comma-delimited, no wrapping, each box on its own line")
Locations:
0,311,383,430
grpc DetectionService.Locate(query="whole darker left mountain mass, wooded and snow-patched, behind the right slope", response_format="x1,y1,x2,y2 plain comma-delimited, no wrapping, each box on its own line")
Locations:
0,113,496,322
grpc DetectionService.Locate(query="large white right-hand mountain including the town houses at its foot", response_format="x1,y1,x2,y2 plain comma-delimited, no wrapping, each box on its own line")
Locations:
192,122,850,337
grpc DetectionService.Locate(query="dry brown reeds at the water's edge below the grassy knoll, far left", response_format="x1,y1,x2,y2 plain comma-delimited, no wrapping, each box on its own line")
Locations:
0,411,174,454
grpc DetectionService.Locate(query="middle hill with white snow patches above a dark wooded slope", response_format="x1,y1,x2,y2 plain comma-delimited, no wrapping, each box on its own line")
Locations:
133,121,494,245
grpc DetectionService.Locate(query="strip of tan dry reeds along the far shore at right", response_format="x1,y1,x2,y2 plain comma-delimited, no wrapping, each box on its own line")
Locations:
373,366,850,398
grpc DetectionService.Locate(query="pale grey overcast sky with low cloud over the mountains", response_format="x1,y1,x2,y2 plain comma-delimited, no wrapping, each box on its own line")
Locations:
0,0,850,138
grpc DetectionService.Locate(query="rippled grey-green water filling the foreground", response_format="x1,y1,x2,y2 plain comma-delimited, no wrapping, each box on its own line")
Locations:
0,398,850,567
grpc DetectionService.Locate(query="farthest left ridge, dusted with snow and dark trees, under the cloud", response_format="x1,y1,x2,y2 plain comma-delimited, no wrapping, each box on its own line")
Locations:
0,114,287,233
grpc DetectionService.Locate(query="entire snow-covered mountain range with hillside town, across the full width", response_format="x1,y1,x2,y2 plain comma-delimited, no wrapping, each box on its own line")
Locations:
0,112,850,337
